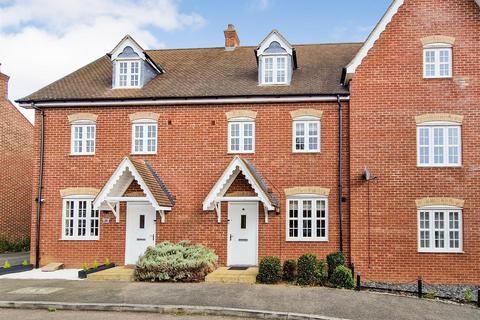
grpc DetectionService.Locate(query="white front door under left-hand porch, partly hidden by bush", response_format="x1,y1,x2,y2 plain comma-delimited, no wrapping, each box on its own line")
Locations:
125,202,156,264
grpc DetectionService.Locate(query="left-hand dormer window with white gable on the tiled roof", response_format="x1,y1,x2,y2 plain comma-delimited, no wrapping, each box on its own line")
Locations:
109,36,164,89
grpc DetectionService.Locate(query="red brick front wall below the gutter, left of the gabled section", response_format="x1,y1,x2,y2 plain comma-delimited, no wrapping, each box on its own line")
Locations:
32,103,349,267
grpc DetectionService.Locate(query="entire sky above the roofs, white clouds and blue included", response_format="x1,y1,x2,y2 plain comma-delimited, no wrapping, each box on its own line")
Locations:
0,0,391,119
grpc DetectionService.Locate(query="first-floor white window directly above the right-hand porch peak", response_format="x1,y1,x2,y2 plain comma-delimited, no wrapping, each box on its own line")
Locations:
228,118,255,153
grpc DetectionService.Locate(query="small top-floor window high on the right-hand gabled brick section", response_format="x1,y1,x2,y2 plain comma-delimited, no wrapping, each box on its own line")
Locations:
423,44,452,78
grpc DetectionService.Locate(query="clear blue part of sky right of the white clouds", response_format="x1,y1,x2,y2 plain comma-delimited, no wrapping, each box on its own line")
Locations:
154,0,390,48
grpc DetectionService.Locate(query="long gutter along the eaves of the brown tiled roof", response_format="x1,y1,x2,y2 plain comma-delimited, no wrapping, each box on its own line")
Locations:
17,94,350,109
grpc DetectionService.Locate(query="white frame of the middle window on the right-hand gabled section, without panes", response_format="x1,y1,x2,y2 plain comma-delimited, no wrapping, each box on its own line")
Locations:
417,121,462,167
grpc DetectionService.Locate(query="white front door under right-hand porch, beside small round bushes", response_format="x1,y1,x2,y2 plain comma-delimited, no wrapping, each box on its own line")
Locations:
227,202,258,266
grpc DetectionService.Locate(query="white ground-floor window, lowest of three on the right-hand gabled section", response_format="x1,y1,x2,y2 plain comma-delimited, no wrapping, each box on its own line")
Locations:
418,208,463,252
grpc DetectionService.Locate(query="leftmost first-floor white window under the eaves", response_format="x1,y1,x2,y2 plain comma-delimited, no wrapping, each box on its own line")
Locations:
71,121,96,155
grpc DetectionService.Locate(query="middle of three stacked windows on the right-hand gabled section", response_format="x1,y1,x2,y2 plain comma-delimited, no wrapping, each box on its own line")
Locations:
417,122,461,167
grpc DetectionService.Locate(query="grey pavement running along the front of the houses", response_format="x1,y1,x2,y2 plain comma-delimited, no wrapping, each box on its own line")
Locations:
0,279,480,320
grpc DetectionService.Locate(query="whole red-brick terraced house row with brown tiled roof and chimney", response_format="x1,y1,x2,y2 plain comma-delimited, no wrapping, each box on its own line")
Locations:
19,0,480,284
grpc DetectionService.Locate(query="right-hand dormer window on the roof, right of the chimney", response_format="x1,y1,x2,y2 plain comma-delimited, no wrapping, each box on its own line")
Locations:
256,30,295,85
